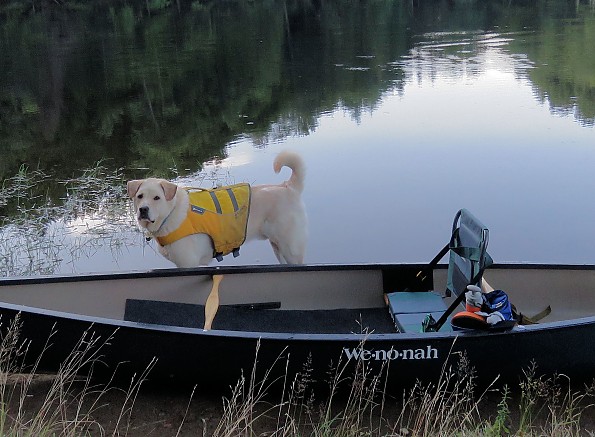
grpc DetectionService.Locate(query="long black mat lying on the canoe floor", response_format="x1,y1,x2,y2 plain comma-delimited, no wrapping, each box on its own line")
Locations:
124,299,395,334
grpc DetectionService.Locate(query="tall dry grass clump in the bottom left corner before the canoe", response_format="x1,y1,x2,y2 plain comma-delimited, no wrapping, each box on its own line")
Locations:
0,316,154,437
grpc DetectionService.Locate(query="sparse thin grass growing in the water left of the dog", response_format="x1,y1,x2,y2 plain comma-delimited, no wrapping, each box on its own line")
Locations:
0,162,143,276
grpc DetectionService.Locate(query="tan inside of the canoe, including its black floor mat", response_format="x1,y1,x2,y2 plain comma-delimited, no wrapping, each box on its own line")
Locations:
0,265,595,333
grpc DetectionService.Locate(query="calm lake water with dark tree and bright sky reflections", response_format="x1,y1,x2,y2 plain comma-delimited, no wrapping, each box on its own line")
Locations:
0,0,595,275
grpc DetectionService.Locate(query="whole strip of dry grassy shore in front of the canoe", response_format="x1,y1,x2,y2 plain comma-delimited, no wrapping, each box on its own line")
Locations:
0,320,595,437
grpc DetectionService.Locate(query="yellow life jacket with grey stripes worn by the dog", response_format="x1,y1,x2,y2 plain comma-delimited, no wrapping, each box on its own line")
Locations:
155,184,250,261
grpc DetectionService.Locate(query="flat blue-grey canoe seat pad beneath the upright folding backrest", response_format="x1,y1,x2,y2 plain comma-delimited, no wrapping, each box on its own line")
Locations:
386,291,451,332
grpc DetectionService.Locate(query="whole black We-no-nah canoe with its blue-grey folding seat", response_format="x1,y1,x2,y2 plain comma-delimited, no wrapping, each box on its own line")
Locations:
0,210,595,391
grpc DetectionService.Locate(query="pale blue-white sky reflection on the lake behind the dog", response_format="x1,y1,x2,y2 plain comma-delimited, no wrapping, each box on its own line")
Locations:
7,25,595,272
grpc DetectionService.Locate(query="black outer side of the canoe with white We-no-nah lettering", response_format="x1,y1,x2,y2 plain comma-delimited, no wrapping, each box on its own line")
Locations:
0,266,595,391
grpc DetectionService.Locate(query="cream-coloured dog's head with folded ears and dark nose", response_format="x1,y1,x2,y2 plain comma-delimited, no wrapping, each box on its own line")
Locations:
126,178,178,231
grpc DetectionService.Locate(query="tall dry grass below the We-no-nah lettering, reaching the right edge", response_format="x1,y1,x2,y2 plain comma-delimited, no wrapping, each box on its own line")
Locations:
205,344,595,437
